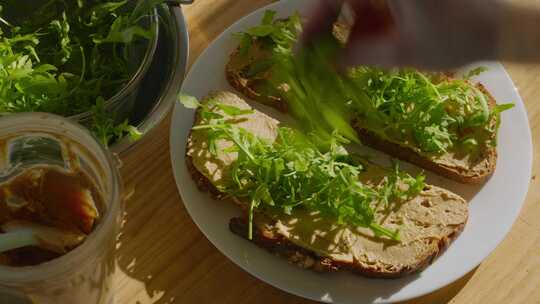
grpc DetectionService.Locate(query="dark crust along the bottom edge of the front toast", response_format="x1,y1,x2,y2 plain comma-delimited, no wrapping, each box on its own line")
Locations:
229,217,465,279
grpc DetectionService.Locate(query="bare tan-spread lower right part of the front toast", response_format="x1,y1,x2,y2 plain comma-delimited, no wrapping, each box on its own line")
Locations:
229,186,467,278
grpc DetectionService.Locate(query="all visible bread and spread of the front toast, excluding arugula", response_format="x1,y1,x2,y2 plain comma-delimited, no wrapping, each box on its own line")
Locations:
186,92,468,278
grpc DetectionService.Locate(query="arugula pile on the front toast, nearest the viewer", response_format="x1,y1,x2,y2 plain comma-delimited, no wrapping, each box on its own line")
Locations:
179,95,424,241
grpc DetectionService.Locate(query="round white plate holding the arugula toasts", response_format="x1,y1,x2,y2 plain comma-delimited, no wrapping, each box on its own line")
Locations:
170,0,532,303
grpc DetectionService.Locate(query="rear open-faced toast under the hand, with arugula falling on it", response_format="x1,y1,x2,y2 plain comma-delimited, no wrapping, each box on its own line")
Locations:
226,11,512,183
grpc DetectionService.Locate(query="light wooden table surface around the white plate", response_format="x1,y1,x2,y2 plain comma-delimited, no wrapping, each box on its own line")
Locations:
116,0,540,304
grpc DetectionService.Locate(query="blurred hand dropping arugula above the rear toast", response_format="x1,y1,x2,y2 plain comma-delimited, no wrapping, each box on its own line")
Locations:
302,0,502,70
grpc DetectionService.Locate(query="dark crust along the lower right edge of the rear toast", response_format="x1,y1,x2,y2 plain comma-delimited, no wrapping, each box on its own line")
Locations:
353,83,497,184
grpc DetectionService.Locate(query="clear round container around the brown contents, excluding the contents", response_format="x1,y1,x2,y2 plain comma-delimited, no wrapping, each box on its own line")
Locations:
0,113,123,304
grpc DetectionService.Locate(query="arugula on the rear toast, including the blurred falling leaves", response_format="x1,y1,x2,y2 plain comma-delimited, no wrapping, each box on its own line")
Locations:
240,11,513,155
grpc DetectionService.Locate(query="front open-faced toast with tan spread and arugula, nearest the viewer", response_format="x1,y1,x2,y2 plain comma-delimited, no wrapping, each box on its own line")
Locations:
182,92,468,278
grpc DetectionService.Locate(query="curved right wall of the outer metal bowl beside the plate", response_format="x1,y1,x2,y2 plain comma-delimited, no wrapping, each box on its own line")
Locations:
110,1,189,154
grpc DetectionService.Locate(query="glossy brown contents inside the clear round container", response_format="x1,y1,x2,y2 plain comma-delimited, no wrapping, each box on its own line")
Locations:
0,166,103,266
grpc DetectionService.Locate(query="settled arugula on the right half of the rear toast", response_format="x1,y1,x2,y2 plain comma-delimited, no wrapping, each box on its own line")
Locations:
343,67,514,155
